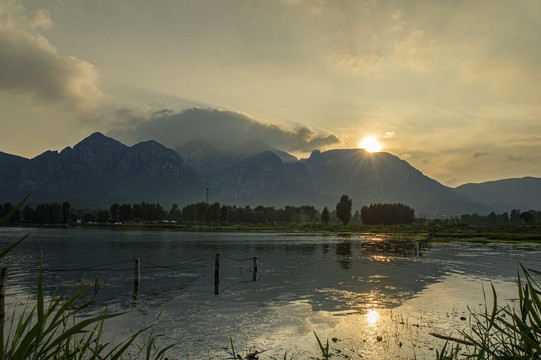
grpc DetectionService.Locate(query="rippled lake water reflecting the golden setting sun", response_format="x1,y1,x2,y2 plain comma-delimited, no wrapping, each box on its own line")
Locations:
0,228,541,359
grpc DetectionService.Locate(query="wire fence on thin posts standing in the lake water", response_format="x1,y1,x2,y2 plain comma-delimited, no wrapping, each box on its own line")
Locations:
0,254,259,310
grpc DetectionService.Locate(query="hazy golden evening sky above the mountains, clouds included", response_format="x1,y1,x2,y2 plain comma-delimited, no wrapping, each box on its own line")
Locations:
0,0,541,186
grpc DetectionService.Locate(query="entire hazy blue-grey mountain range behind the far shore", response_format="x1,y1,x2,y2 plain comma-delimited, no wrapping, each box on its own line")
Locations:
0,133,541,216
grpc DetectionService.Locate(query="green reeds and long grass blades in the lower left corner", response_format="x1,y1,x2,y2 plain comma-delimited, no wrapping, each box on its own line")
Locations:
0,195,173,360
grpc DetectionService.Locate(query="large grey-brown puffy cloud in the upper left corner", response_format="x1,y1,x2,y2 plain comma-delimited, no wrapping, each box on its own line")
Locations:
0,0,103,111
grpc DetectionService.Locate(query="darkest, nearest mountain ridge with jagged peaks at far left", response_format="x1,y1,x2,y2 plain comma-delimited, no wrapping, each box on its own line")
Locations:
0,133,203,208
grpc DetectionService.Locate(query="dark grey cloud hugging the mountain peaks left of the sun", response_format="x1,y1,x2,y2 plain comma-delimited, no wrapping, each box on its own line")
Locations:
109,108,340,152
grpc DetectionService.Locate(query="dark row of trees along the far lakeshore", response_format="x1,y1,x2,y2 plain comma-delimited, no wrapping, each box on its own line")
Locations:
0,195,414,225
